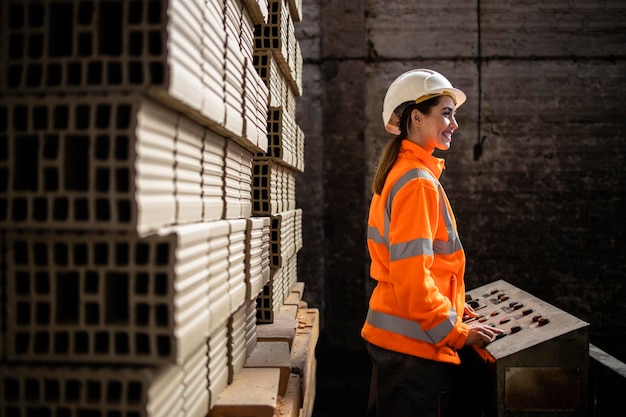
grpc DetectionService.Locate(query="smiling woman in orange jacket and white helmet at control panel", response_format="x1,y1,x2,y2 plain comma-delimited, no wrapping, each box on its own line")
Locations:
362,69,502,417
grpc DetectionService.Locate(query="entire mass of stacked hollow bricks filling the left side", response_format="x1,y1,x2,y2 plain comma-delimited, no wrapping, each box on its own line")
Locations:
0,0,318,417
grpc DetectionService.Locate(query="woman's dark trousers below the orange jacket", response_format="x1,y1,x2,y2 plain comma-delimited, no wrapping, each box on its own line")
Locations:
366,342,459,417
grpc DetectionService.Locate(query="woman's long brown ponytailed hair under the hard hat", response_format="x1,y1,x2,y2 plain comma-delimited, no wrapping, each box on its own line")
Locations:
372,96,441,194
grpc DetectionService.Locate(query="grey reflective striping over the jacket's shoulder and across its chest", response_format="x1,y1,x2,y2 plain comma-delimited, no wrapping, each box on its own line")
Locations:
367,168,463,254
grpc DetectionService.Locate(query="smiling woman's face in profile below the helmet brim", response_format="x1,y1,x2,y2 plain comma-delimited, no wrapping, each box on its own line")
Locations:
414,96,459,152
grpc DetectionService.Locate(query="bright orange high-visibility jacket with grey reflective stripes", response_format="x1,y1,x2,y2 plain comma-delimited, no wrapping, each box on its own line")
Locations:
361,139,468,364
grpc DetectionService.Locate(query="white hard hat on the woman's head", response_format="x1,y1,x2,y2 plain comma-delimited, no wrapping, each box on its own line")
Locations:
383,68,467,135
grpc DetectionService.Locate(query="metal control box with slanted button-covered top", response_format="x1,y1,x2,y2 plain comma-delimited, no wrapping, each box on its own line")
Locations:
466,280,589,417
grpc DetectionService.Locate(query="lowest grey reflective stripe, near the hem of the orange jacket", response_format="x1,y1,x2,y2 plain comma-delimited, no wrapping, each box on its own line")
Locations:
367,308,457,344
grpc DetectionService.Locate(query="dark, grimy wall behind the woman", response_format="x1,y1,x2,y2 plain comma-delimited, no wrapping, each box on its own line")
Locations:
297,0,626,360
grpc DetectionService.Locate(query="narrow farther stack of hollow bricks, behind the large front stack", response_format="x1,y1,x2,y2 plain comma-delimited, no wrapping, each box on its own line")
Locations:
252,0,304,323
